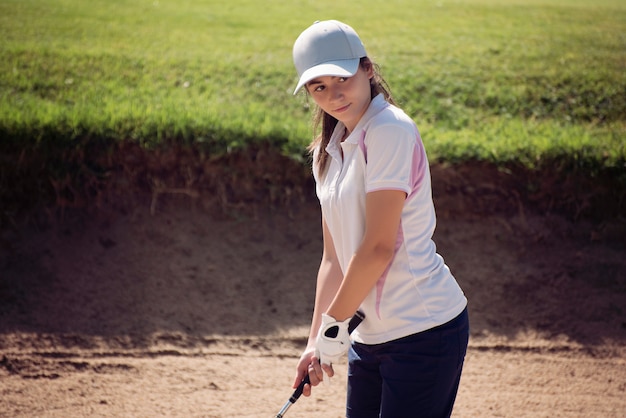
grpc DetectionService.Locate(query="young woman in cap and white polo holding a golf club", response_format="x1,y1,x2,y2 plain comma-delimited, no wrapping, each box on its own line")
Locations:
293,20,469,418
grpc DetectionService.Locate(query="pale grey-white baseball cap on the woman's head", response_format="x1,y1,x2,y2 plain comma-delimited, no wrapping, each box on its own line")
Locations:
293,20,367,94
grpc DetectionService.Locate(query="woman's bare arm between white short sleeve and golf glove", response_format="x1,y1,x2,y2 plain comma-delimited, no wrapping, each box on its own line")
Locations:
326,190,406,321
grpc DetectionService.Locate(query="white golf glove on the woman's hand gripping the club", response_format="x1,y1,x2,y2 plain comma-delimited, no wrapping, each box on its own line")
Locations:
315,314,350,365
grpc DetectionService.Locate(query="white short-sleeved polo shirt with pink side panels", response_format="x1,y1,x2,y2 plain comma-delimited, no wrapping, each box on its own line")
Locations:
313,94,467,344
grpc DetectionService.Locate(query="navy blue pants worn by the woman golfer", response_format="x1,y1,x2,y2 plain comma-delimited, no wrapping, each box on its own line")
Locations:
346,309,469,418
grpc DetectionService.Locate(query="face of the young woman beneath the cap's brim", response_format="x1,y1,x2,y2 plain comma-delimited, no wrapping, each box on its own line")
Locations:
306,65,374,132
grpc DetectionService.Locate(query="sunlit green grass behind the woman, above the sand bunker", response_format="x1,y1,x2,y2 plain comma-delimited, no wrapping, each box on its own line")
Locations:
0,0,626,170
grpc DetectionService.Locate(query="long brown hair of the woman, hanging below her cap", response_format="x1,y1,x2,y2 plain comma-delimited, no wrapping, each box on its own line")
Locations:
307,57,395,173
